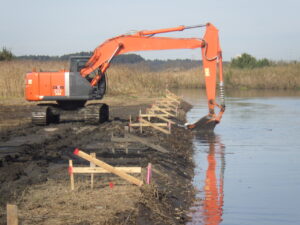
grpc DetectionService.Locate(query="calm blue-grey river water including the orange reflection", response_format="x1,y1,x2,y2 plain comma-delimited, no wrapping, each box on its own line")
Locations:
177,90,300,225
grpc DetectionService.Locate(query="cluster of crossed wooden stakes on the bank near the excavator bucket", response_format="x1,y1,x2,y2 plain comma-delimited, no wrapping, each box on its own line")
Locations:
129,90,181,134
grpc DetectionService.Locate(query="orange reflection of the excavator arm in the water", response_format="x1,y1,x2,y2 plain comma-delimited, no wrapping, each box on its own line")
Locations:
189,133,225,225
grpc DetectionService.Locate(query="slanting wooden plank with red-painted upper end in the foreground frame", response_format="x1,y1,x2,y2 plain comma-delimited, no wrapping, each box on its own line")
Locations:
74,149,143,186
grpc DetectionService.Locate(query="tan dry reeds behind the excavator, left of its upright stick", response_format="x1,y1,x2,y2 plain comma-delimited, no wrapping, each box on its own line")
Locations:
0,60,204,98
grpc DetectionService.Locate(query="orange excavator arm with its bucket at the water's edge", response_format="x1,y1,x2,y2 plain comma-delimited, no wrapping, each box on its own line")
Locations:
80,23,225,129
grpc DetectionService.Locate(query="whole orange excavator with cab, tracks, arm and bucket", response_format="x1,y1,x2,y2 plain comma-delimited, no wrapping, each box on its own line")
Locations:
25,23,225,129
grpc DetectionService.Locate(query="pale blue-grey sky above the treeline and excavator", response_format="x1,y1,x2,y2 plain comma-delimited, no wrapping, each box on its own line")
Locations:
0,0,300,60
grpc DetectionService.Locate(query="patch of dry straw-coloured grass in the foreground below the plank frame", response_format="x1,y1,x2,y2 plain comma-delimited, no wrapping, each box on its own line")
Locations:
17,176,140,225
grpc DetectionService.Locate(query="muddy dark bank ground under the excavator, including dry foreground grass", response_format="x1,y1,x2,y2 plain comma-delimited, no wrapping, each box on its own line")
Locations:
0,100,194,225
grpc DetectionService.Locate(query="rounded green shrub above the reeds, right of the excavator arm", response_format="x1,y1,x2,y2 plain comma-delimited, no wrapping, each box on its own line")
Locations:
230,53,271,69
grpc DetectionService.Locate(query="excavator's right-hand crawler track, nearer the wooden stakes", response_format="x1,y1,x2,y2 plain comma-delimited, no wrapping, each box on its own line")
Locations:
83,104,109,124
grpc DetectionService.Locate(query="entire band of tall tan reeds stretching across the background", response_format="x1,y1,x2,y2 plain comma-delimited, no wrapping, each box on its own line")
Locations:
0,60,300,101
